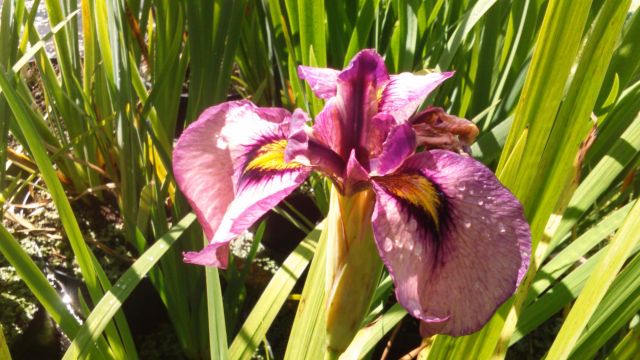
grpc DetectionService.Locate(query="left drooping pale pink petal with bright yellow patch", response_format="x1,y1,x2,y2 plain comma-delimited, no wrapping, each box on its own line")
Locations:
174,101,309,268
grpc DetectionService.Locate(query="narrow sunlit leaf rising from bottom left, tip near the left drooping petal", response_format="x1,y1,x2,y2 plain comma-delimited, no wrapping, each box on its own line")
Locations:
63,214,196,360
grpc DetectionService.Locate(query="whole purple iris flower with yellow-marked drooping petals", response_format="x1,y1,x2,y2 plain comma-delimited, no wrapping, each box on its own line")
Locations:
173,50,531,336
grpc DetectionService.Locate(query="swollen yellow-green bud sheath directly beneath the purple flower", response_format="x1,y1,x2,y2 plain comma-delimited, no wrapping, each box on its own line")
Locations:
325,188,382,359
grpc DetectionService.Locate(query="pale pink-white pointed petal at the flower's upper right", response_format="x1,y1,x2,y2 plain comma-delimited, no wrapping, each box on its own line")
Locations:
380,72,453,123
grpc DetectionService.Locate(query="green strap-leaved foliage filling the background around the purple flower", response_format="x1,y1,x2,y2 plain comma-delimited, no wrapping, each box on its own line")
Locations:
0,0,640,359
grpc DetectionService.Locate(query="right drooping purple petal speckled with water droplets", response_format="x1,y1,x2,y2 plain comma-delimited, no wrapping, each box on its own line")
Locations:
373,150,531,336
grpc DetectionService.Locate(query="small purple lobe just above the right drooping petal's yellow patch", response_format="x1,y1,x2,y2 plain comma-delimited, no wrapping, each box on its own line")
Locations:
371,123,416,175
